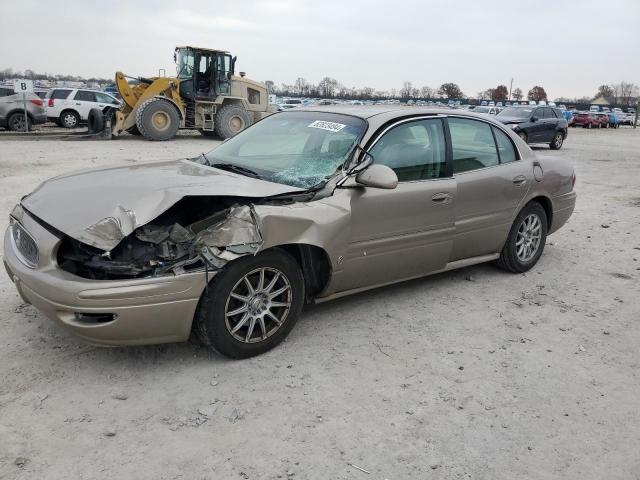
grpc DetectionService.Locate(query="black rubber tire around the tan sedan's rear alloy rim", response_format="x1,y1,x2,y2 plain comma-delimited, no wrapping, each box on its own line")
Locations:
496,202,547,273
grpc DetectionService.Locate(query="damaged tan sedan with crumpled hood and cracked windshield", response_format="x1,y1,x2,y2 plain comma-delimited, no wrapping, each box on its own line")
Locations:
4,106,576,358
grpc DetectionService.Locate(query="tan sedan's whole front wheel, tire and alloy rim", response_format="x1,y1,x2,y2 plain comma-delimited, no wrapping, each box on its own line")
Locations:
194,250,304,358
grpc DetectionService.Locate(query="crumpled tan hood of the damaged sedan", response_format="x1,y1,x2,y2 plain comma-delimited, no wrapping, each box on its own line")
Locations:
22,160,303,251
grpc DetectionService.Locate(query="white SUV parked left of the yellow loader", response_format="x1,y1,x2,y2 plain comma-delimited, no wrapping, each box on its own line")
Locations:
45,88,120,128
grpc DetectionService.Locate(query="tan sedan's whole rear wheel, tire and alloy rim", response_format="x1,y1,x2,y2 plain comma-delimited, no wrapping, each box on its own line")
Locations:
496,202,547,273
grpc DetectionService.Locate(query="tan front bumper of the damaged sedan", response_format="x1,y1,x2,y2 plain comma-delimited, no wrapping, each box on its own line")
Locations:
4,213,214,346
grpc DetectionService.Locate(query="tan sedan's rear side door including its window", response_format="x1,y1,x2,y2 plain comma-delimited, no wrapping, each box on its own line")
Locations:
448,117,533,261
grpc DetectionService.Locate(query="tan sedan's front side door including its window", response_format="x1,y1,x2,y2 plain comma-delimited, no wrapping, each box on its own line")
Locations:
336,118,456,291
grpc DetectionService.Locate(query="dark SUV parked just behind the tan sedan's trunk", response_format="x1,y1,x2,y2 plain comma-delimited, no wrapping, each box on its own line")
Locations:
496,105,569,150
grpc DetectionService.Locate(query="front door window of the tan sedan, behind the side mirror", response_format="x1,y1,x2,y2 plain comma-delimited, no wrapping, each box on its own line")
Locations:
371,119,446,182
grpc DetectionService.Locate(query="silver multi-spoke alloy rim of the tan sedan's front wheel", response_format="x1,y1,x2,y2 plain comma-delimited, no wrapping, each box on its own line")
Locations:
224,267,293,343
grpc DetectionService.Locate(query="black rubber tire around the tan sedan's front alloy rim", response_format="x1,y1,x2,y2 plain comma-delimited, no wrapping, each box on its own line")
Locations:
194,249,304,358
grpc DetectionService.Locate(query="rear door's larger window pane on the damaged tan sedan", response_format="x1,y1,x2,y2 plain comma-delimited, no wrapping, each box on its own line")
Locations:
448,118,500,173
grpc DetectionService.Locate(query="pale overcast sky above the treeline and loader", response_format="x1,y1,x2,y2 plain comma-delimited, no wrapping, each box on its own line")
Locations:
0,0,640,98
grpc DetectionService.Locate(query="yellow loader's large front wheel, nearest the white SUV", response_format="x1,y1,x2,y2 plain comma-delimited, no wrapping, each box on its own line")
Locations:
136,98,180,141
